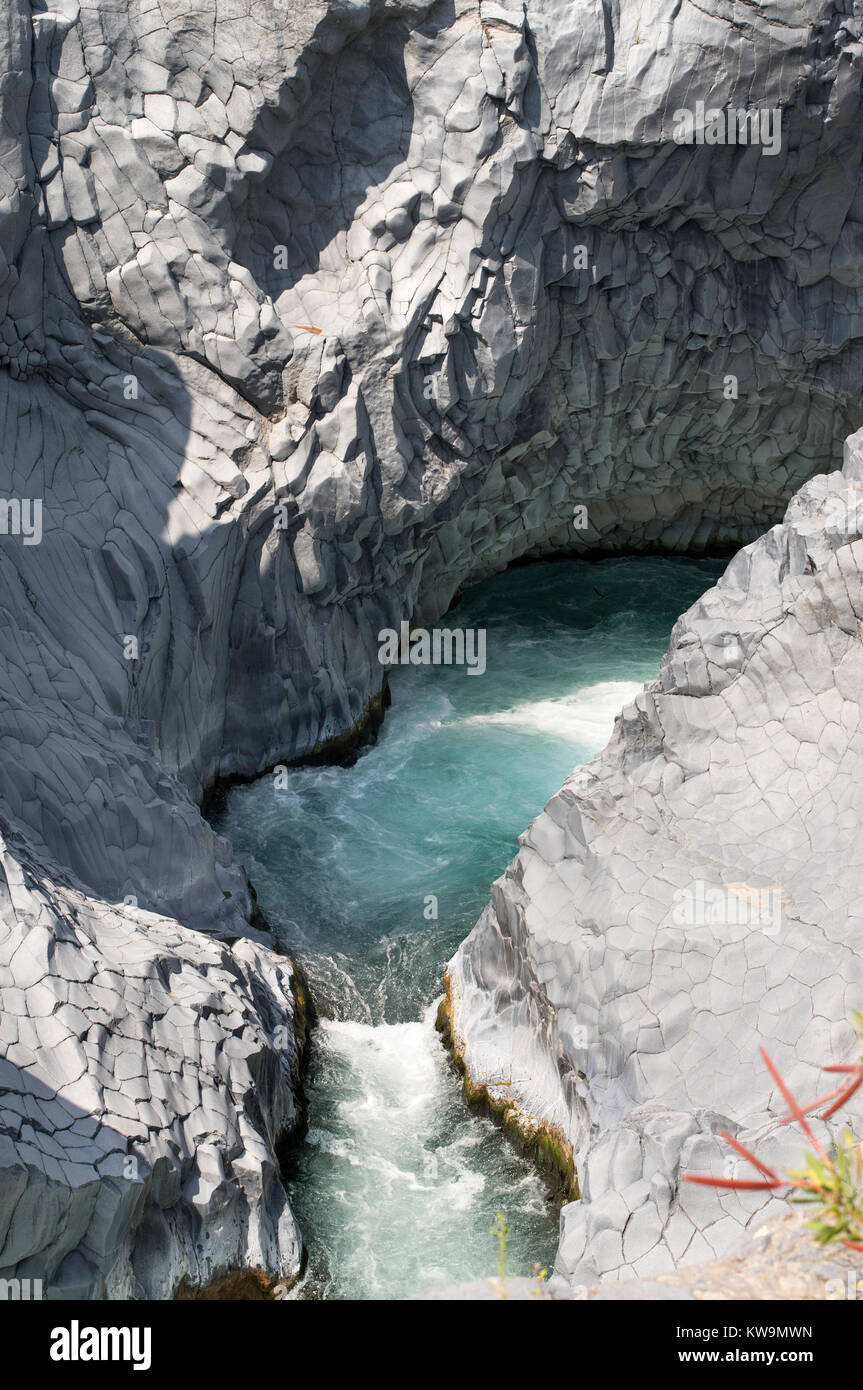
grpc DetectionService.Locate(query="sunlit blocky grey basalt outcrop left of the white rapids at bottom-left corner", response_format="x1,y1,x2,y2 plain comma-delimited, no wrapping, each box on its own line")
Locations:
0,817,300,1298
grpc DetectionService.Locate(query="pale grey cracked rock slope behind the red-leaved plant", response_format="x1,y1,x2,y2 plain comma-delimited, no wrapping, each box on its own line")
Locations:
447,434,863,1284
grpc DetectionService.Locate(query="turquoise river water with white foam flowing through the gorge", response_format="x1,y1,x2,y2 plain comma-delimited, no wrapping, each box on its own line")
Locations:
217,559,723,1298
